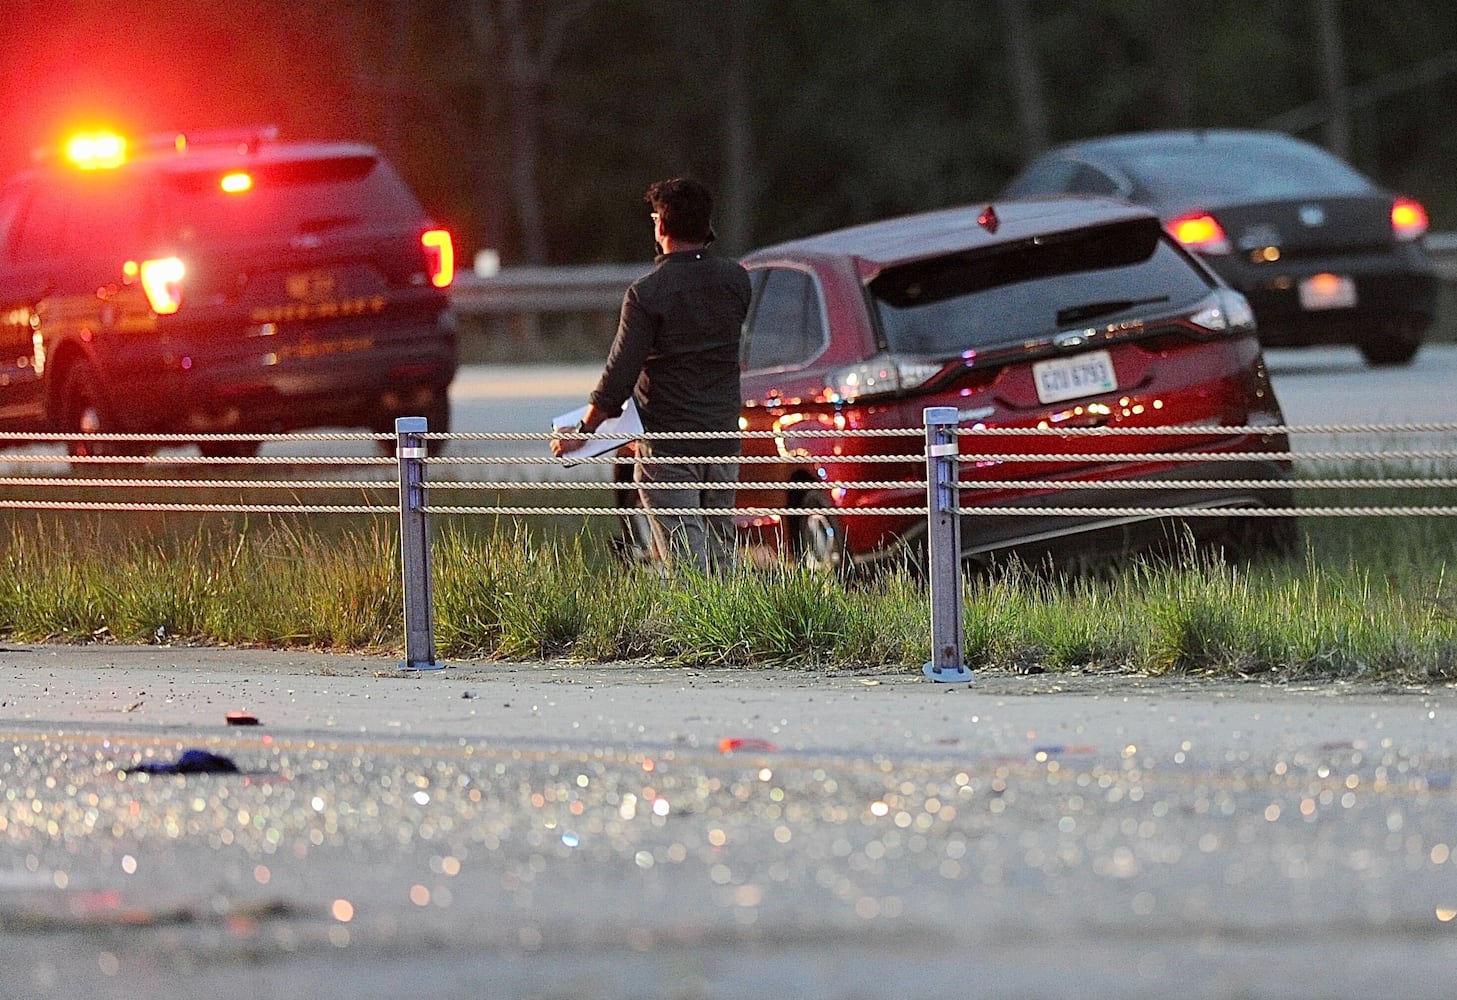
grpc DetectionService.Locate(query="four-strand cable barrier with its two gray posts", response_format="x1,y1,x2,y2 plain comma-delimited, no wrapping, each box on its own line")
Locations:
0,407,1457,682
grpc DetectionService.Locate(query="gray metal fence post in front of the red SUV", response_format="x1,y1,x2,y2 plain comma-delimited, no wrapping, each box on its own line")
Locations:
922,407,972,684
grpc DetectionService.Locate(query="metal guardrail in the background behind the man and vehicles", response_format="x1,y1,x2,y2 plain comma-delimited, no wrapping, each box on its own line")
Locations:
450,233,1457,315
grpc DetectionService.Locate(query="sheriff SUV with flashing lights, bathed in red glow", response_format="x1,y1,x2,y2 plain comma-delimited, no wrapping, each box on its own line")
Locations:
0,130,456,455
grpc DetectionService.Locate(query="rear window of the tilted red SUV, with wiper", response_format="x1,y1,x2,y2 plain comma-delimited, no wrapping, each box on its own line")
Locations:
870,219,1212,357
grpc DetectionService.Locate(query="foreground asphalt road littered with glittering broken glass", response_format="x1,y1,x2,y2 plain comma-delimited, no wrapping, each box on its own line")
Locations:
0,646,1457,1000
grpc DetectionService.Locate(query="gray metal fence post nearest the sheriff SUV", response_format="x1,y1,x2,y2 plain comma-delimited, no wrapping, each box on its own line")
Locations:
395,417,441,671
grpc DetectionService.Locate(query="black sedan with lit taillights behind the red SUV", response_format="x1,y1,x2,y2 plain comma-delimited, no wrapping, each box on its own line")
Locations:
1002,130,1437,364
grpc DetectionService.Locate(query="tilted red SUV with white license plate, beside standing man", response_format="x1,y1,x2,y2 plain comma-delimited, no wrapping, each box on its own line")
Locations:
620,198,1294,569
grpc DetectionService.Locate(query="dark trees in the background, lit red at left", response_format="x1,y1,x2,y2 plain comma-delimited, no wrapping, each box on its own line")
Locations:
0,0,1457,264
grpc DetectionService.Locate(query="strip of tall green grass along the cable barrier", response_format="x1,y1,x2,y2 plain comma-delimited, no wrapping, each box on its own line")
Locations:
0,494,1457,681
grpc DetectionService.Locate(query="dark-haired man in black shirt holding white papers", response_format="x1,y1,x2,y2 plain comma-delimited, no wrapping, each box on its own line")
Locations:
552,178,749,573
